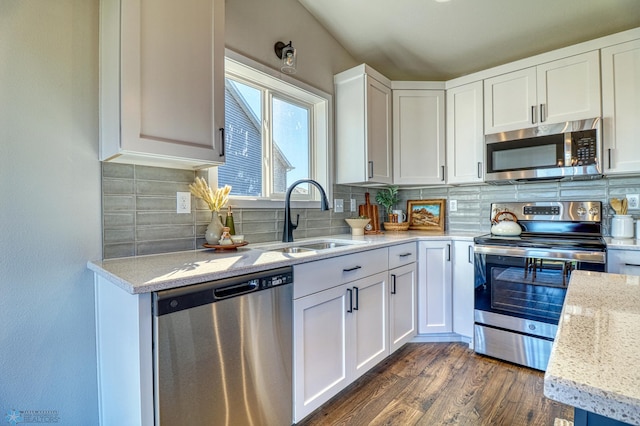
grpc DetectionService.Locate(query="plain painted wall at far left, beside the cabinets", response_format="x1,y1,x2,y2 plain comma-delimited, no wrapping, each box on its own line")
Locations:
0,0,101,425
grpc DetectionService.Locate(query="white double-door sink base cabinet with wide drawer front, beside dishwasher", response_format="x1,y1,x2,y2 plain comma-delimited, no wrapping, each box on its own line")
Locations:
293,249,389,422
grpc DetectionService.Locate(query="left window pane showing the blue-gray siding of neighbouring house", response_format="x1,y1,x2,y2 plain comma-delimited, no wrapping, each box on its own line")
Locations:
218,78,263,196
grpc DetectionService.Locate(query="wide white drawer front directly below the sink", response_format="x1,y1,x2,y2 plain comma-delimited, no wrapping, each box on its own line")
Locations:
293,248,389,299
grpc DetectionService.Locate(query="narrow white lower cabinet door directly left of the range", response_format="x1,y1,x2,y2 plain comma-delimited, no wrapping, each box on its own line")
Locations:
453,241,475,339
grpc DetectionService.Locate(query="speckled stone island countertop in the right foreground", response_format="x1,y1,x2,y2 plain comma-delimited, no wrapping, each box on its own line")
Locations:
544,271,640,425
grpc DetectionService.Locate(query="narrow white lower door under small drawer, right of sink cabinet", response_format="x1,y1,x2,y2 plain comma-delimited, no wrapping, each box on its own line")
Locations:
389,263,417,353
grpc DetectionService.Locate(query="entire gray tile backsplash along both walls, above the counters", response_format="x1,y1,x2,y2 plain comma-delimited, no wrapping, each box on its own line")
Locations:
102,163,640,259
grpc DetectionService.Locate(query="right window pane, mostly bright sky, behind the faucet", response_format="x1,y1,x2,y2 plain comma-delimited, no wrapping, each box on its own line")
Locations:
272,97,310,194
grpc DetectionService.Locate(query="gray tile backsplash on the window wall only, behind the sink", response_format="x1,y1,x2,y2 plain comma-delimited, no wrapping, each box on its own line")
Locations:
102,163,366,259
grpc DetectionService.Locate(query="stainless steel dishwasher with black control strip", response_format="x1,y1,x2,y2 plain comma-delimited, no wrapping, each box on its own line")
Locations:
153,267,293,426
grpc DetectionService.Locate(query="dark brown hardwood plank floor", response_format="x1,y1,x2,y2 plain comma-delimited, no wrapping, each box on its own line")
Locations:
298,343,573,426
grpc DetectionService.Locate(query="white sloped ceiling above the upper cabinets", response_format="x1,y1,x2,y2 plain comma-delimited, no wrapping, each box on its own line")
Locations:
299,0,640,81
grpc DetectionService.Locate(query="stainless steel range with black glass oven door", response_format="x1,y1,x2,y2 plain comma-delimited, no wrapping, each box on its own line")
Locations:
474,201,606,371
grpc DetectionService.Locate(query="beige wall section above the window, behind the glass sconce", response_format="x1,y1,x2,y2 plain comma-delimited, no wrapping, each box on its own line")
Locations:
225,0,358,94
